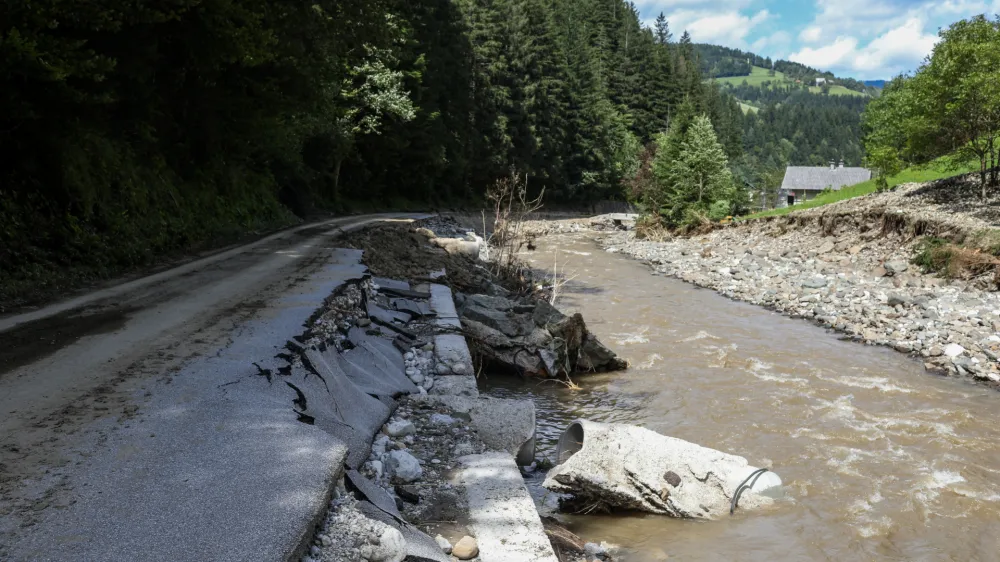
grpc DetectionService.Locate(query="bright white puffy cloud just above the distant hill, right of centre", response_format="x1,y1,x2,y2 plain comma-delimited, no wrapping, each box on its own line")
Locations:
789,18,938,78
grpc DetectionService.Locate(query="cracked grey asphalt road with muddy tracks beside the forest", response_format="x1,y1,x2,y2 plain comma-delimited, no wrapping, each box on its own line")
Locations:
0,215,424,560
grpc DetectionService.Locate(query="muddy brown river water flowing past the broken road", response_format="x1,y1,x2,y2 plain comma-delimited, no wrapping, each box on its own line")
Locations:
487,230,1000,562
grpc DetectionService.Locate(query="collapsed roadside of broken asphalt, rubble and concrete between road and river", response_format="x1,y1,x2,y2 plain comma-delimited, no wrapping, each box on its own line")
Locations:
297,219,625,562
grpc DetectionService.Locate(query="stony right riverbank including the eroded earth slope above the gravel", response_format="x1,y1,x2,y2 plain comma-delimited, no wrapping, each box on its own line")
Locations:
531,175,1000,388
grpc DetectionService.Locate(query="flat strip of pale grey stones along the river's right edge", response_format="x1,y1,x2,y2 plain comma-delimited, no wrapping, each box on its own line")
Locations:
601,224,1000,387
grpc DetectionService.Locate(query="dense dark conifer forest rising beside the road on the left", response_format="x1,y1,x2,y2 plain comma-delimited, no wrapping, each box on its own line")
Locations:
0,0,872,304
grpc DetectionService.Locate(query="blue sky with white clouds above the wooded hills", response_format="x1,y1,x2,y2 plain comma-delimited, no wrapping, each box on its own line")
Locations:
633,0,1000,79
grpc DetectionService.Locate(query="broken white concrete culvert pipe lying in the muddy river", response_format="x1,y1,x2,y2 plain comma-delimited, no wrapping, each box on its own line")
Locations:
543,420,781,519
